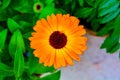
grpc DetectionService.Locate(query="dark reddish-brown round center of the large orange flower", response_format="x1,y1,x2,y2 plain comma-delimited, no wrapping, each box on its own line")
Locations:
49,31,67,49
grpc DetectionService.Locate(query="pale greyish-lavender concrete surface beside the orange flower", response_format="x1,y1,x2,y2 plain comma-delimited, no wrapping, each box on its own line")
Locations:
60,34,120,80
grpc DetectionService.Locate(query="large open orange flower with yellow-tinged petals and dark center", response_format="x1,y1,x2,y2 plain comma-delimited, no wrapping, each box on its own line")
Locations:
30,14,87,68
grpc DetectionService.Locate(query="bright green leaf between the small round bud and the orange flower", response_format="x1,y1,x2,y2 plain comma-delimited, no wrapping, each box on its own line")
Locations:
39,3,55,19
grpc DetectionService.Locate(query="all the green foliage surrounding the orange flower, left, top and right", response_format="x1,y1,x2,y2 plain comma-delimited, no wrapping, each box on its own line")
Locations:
0,0,120,80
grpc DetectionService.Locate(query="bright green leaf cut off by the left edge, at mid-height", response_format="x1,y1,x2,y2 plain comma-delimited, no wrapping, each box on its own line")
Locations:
0,29,7,49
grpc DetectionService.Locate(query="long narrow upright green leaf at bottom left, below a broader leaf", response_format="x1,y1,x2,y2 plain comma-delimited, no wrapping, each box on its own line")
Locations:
14,47,24,79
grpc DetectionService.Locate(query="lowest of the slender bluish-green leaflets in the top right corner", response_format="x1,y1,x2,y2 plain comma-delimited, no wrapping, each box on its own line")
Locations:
100,8,120,24
